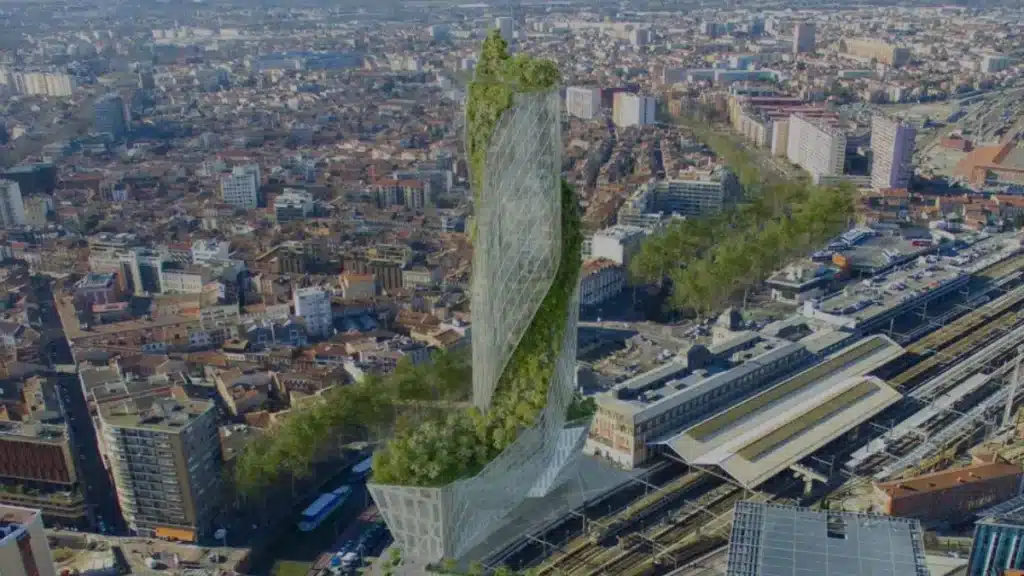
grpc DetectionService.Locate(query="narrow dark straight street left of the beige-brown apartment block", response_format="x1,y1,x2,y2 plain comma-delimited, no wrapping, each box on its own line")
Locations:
33,278,124,534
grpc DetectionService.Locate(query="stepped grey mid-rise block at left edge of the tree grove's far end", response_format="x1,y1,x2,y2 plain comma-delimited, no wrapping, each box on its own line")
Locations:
617,168,742,224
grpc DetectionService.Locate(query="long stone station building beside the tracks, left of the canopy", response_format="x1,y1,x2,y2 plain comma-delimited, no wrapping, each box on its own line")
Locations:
584,332,810,469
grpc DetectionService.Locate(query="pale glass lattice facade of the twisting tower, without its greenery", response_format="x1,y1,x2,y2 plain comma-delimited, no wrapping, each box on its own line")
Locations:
370,86,587,562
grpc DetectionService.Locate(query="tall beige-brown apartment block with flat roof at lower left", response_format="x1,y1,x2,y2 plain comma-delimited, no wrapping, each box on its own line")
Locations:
98,393,222,542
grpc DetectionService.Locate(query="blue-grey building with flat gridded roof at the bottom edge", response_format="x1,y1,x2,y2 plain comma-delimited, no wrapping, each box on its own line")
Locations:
725,500,932,576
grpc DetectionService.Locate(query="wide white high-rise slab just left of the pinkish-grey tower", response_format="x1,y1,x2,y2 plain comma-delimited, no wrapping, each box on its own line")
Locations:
786,114,846,183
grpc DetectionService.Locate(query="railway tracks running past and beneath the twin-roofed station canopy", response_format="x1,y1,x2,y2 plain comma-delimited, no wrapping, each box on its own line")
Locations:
487,242,1024,576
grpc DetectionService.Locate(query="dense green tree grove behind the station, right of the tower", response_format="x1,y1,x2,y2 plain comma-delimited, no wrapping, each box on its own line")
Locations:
630,114,853,316
